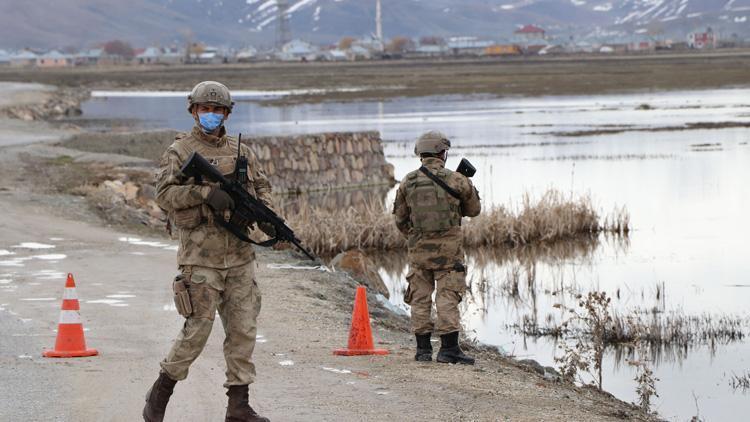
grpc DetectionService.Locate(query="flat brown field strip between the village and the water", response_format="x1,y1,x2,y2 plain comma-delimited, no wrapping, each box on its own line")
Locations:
0,50,750,102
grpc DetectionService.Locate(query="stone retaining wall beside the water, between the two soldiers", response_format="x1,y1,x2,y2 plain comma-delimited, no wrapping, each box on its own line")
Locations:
248,132,395,193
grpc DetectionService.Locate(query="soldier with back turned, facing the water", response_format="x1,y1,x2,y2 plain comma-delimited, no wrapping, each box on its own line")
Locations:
393,132,482,365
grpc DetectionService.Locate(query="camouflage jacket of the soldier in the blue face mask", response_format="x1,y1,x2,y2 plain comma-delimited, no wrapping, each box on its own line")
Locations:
156,126,271,269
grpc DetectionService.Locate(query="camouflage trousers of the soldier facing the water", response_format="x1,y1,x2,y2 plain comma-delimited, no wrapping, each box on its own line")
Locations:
404,266,466,335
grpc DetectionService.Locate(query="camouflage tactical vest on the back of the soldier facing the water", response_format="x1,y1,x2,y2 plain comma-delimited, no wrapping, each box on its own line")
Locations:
403,169,461,233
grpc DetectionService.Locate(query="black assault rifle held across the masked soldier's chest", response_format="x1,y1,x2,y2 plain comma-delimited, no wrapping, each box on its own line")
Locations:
181,148,318,262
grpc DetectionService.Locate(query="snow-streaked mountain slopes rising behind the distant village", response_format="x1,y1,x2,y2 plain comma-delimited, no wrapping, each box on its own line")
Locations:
0,0,750,48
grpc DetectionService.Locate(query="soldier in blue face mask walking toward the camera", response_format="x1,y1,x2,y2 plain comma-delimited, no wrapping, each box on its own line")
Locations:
143,81,273,422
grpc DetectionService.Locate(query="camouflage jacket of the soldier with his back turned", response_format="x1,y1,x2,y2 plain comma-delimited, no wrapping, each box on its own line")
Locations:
393,158,482,270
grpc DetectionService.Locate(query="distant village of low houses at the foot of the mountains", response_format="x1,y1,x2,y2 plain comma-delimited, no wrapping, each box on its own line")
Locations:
0,25,744,68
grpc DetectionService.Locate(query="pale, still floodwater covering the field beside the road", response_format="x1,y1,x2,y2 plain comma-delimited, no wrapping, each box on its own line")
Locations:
80,89,750,420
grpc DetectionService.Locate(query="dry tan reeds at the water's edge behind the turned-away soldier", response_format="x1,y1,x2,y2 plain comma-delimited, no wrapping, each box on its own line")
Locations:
286,190,630,255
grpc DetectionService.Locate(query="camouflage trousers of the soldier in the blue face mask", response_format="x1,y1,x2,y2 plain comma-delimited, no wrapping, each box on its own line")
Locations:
161,261,261,387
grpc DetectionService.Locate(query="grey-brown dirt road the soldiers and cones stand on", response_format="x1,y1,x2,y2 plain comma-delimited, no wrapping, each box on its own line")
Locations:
0,84,656,421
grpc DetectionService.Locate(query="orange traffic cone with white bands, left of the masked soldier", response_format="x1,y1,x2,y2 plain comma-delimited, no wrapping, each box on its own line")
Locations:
42,274,99,358
